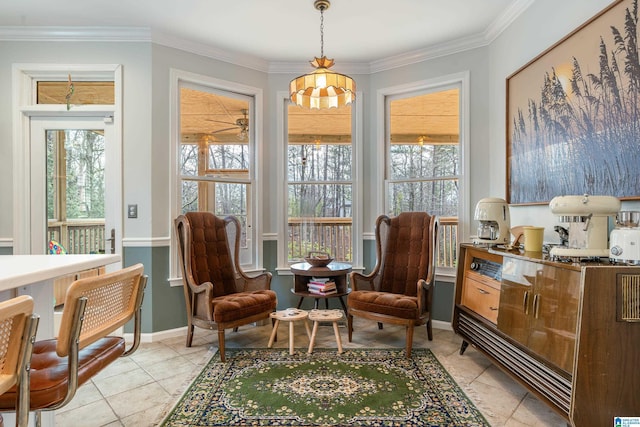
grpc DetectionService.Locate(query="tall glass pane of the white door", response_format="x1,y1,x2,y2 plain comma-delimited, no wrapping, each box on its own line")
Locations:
46,129,105,254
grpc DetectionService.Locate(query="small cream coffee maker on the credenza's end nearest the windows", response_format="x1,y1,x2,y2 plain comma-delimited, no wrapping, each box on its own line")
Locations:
474,197,511,245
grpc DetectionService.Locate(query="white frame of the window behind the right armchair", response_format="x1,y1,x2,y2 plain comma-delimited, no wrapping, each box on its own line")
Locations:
377,71,470,281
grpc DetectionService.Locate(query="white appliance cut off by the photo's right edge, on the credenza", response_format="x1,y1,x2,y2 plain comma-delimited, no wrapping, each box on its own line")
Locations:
609,211,640,265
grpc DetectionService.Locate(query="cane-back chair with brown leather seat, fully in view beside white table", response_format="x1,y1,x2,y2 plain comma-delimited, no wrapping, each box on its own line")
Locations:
0,264,147,426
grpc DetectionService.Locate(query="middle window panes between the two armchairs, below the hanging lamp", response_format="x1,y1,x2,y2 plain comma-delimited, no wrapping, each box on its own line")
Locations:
285,103,357,263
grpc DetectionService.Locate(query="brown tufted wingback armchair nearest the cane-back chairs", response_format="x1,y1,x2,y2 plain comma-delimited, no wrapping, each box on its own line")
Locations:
175,212,277,362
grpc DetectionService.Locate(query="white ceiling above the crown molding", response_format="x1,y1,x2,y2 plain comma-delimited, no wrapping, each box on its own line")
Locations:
0,0,534,65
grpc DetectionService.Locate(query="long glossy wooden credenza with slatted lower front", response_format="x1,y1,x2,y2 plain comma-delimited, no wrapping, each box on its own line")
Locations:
453,244,640,427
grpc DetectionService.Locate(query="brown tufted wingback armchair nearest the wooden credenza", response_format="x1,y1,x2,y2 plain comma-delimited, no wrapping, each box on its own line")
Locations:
347,212,438,357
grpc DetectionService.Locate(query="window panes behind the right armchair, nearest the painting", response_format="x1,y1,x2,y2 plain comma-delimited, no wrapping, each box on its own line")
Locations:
385,87,461,267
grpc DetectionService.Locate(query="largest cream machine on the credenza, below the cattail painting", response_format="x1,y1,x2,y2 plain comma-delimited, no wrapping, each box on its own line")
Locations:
549,194,620,258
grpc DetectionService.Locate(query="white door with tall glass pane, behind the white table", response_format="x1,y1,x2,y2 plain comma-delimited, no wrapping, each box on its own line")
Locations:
29,117,122,270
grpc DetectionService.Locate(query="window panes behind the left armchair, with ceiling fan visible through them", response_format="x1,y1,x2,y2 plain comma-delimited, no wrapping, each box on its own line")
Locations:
177,78,258,268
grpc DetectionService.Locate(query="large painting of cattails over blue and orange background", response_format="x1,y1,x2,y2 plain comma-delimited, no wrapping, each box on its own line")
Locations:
507,0,640,204
